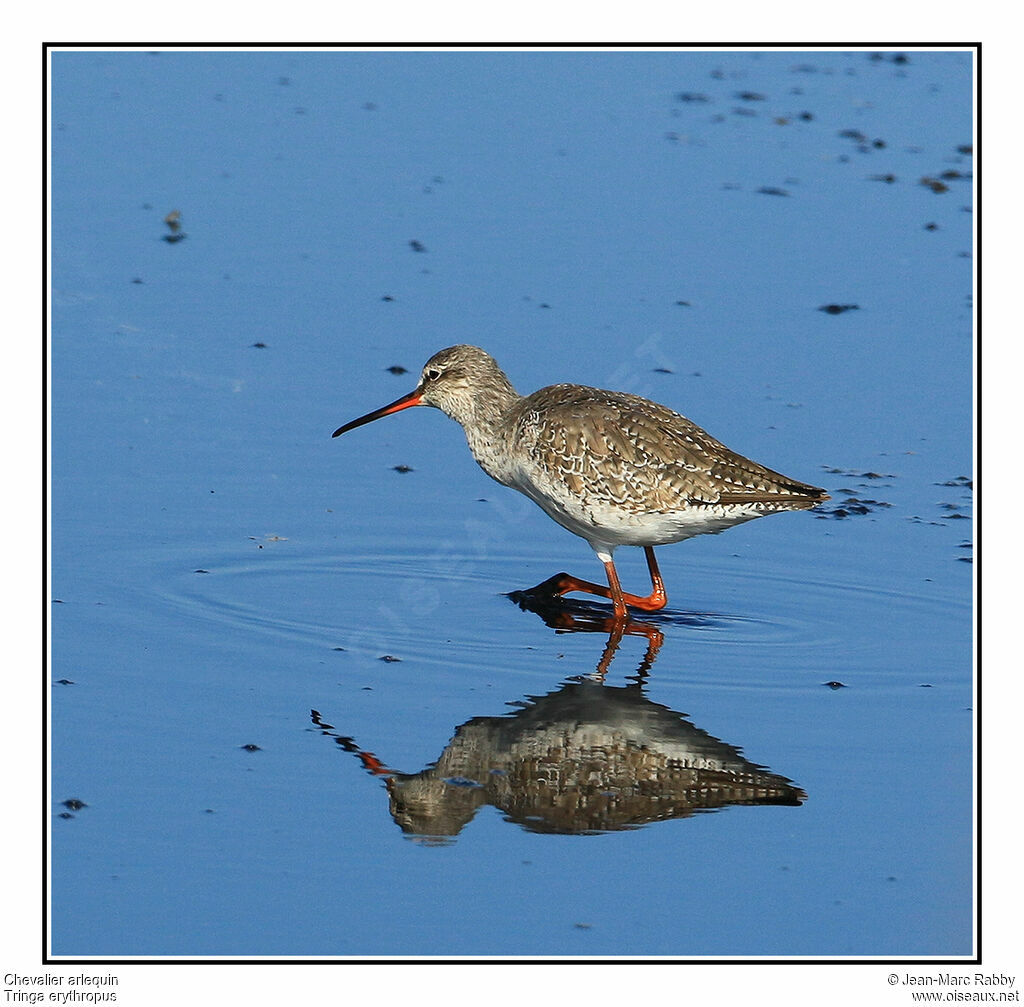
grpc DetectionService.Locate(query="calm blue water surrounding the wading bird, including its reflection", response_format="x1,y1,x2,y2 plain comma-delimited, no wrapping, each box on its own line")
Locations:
50,52,975,959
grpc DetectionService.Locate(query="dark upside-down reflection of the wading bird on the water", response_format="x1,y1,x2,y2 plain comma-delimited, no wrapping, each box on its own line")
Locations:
312,595,807,844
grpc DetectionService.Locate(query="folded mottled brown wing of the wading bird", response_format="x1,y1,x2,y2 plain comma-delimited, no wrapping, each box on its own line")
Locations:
507,385,826,512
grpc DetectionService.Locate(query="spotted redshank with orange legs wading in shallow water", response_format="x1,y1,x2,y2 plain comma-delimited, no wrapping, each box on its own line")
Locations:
333,345,828,619
